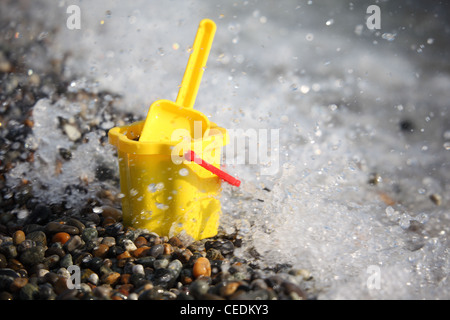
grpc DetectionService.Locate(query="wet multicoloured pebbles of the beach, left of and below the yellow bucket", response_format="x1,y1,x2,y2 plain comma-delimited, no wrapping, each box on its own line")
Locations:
0,21,314,300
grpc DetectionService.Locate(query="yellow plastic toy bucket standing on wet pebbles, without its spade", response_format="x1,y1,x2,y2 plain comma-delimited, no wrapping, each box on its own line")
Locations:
108,121,228,240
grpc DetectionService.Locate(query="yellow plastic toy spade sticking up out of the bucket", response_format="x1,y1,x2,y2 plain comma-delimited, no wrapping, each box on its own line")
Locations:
139,19,216,142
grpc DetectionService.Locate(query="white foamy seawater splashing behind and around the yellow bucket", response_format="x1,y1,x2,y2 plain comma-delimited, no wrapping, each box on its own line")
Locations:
4,1,450,299
